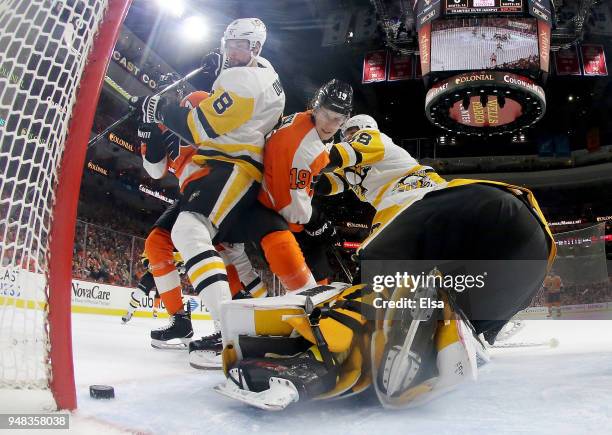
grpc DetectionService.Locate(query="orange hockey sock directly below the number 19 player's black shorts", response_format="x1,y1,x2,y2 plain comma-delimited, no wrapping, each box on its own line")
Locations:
261,230,317,291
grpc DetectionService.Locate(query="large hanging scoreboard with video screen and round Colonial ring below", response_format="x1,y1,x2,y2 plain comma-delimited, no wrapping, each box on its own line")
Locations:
416,0,551,136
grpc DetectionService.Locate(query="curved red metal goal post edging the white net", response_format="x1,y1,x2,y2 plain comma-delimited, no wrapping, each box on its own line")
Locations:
48,0,132,409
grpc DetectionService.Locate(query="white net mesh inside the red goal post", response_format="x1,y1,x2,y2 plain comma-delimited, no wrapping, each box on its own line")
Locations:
0,0,108,389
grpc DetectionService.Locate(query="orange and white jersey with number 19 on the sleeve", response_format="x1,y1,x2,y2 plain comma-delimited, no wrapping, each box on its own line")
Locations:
259,111,329,231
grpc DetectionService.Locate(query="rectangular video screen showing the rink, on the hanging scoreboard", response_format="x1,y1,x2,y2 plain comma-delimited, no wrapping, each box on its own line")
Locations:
431,18,540,72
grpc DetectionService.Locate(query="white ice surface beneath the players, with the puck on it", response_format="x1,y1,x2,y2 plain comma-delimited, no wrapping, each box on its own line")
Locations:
51,314,612,434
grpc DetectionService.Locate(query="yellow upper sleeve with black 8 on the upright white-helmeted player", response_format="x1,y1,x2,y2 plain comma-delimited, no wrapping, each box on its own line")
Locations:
187,87,255,145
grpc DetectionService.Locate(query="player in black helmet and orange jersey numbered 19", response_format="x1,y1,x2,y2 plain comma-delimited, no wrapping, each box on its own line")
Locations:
259,79,353,284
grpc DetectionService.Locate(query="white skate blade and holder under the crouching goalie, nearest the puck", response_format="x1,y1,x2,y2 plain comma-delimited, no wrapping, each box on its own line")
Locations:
214,377,300,411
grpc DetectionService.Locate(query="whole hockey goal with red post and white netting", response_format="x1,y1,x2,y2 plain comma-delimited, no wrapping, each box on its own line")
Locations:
0,0,130,411
